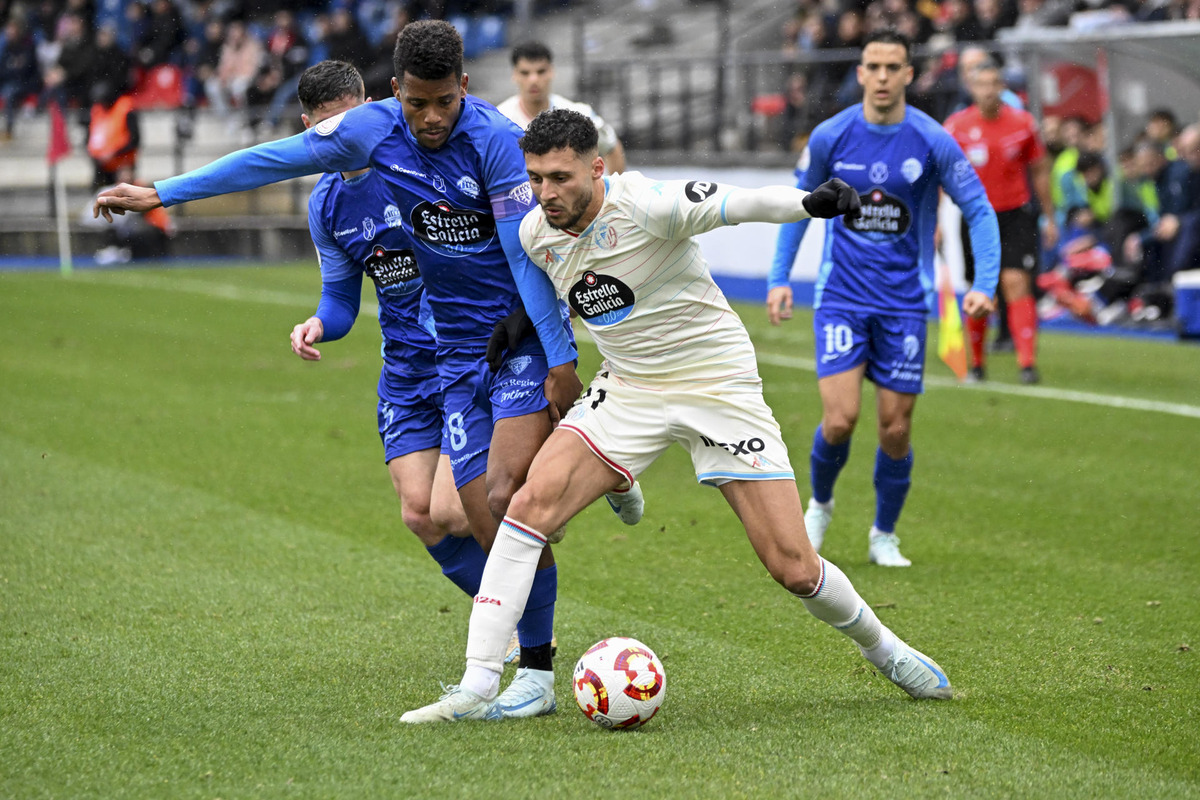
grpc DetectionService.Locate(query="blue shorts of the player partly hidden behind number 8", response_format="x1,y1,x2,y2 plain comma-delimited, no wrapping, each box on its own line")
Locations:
376,371,445,463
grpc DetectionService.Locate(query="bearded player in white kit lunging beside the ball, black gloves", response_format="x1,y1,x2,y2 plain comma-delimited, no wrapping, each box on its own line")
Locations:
401,109,953,722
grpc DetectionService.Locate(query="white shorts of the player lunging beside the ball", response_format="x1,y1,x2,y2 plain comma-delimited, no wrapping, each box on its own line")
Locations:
559,369,796,486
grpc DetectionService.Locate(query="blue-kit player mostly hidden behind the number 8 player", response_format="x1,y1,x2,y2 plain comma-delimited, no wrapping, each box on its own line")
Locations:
292,61,487,623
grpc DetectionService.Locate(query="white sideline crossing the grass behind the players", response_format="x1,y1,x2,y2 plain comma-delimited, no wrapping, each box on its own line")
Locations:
74,271,1200,419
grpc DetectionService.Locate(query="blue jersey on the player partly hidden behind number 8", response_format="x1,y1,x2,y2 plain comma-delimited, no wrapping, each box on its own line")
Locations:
308,169,436,377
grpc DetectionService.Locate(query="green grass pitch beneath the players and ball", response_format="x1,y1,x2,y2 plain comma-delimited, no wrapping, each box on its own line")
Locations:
0,265,1200,800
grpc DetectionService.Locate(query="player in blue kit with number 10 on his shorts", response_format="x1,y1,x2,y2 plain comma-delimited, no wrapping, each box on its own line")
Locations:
767,30,1000,566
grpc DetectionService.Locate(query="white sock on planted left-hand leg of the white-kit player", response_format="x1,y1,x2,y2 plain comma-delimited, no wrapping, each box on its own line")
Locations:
460,517,546,681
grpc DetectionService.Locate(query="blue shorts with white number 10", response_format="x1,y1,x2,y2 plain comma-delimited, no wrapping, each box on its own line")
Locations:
812,308,925,395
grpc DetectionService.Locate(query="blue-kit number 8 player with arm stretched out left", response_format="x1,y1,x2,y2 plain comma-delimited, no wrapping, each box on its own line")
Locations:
94,20,640,716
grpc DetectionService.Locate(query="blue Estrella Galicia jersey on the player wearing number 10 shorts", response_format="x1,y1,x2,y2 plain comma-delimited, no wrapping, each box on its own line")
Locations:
796,104,986,317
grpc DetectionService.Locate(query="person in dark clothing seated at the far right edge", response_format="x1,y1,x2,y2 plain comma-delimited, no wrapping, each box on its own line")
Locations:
1123,125,1200,283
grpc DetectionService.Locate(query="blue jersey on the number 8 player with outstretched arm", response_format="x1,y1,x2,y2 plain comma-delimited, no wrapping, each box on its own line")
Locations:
305,96,535,348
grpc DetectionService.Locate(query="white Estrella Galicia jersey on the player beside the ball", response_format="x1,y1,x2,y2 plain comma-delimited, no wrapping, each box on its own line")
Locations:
521,172,761,386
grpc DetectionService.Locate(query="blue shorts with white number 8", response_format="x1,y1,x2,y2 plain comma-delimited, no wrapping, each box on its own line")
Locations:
438,336,548,488
